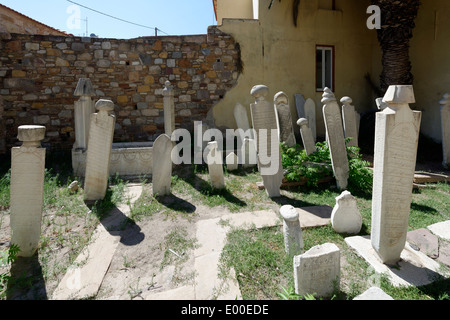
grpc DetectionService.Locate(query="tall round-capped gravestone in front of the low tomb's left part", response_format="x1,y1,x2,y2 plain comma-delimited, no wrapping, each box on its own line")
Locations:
84,100,116,201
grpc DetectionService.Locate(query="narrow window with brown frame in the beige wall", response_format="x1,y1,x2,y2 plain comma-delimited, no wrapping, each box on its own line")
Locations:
316,46,334,91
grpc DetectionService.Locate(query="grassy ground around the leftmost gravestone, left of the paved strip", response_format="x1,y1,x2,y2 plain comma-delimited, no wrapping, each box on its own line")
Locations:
0,160,125,299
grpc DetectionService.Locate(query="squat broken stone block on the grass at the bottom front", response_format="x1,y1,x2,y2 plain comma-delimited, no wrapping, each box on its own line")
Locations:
294,243,341,297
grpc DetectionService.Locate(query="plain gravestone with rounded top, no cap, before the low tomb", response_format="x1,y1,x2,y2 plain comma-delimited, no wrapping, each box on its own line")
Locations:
152,134,173,196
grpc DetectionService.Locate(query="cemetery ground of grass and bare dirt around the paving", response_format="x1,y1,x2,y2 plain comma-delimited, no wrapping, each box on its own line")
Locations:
0,139,450,300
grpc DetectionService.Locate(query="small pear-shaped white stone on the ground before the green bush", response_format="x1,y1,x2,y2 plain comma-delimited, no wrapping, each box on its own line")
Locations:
331,191,362,234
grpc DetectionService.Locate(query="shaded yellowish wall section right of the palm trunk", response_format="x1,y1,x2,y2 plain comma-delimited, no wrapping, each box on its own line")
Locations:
410,0,450,142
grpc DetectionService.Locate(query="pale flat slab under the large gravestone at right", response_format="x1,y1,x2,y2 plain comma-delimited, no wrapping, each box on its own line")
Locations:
345,236,449,287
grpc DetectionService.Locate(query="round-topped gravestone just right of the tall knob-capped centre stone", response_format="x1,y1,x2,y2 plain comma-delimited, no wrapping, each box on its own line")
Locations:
274,92,297,147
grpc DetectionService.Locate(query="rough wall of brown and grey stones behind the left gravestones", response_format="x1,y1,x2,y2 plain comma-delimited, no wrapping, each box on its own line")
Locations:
0,26,241,152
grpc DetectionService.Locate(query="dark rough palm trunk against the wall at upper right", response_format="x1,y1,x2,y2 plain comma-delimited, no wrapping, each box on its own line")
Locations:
269,0,420,94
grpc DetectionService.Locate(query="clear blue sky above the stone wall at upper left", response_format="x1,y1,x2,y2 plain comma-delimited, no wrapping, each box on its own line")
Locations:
0,0,217,39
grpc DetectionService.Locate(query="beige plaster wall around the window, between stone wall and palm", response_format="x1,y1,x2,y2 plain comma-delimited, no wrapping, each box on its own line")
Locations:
213,0,378,136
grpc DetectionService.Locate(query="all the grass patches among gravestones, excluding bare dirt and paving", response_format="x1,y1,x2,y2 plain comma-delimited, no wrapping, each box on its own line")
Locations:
0,151,450,300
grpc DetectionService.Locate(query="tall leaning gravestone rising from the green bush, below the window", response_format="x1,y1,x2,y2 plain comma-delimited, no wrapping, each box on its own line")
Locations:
322,88,349,190
